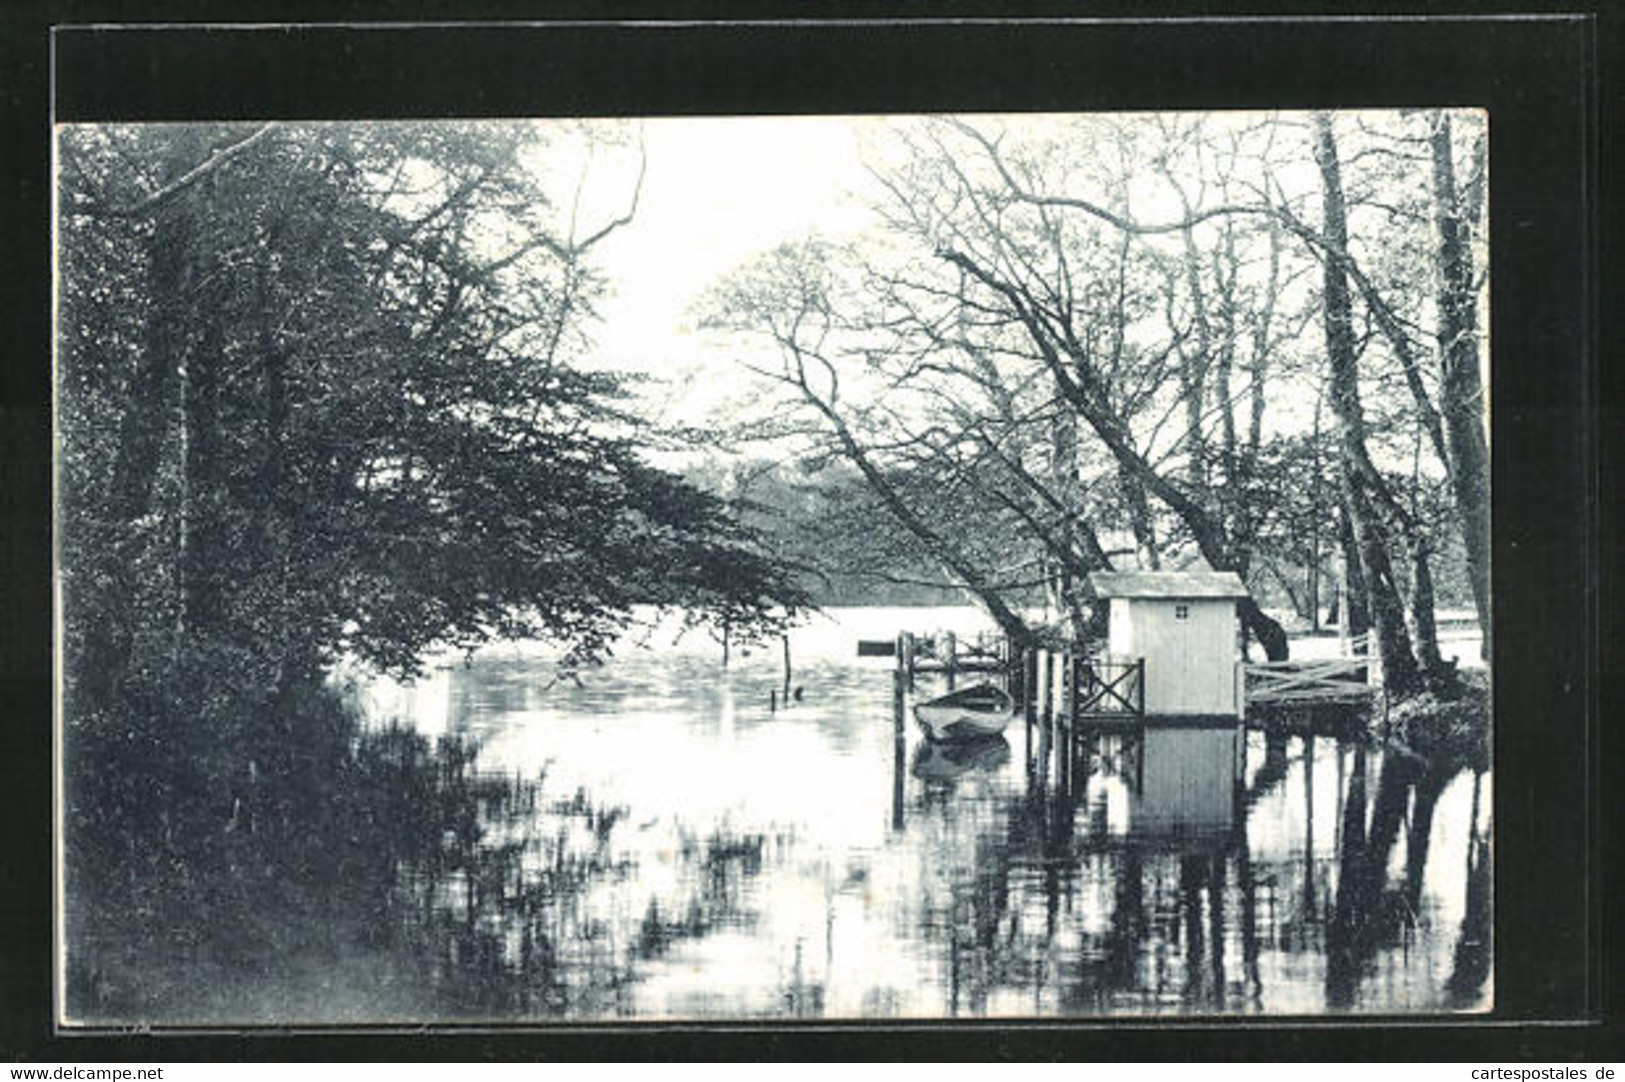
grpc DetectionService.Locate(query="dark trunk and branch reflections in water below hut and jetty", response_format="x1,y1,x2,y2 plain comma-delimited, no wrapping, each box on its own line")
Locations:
920,721,1489,1014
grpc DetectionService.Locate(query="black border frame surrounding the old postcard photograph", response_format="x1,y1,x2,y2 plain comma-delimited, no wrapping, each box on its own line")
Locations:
0,0,1622,1061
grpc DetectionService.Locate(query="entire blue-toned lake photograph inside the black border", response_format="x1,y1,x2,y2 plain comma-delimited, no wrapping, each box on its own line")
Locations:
52,107,1488,1030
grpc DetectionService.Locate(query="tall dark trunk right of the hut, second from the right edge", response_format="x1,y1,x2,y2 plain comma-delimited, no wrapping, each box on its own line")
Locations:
1315,114,1417,695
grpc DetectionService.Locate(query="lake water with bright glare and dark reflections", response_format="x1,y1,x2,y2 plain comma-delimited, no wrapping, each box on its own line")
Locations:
366,609,1492,1020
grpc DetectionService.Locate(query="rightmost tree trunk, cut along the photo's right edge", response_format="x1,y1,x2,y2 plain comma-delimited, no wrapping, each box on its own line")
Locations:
1432,112,1492,660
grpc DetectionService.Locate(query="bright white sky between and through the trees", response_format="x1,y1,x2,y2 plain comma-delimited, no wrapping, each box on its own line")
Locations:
549,114,1488,477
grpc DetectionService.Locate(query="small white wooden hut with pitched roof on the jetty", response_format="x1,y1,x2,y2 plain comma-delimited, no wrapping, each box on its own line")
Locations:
1089,572,1246,718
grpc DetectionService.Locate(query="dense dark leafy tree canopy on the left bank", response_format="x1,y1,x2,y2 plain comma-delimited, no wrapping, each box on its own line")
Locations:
57,123,801,699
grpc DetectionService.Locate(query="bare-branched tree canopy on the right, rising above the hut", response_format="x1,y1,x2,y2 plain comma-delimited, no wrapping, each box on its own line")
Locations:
702,112,1489,690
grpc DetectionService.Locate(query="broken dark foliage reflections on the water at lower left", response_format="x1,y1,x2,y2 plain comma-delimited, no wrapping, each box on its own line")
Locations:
385,741,780,1019
